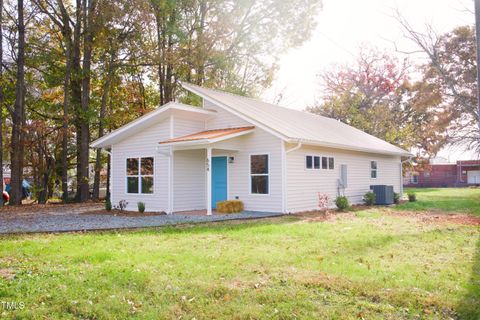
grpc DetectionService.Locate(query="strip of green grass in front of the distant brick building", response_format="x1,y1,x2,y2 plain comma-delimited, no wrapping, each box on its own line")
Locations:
397,188,480,216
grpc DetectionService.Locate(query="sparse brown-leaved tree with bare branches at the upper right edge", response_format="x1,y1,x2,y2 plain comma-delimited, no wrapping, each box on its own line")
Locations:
394,11,480,152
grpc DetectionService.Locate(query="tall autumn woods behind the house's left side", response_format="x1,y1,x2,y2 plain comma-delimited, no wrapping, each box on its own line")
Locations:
0,0,321,204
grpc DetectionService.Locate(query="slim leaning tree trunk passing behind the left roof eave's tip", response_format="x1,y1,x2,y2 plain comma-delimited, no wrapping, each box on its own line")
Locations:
93,52,115,200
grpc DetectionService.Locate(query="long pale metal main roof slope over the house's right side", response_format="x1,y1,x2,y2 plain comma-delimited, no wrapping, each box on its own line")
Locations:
182,83,412,156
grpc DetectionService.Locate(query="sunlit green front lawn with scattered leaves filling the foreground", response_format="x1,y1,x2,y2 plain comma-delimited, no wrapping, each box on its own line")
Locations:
0,190,480,319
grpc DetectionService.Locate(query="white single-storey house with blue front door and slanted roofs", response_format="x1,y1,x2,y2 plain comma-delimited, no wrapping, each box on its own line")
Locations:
91,84,411,214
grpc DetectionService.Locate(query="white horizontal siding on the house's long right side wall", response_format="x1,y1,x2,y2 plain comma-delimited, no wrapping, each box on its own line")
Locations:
287,145,401,212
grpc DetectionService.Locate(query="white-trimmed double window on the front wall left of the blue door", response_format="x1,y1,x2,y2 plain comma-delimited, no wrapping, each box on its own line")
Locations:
127,157,154,194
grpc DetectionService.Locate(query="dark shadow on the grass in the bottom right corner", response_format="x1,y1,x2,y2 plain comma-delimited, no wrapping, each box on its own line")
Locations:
456,234,480,320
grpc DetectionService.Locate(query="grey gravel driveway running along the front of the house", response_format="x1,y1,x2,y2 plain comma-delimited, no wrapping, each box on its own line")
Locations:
0,206,281,234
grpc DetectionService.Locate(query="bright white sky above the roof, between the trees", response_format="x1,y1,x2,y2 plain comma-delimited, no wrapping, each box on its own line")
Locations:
263,0,474,161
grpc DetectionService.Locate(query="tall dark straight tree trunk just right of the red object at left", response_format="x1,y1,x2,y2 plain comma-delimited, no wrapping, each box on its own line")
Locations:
10,0,25,205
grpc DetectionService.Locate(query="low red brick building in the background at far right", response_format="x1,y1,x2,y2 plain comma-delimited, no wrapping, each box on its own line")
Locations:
403,160,480,188
